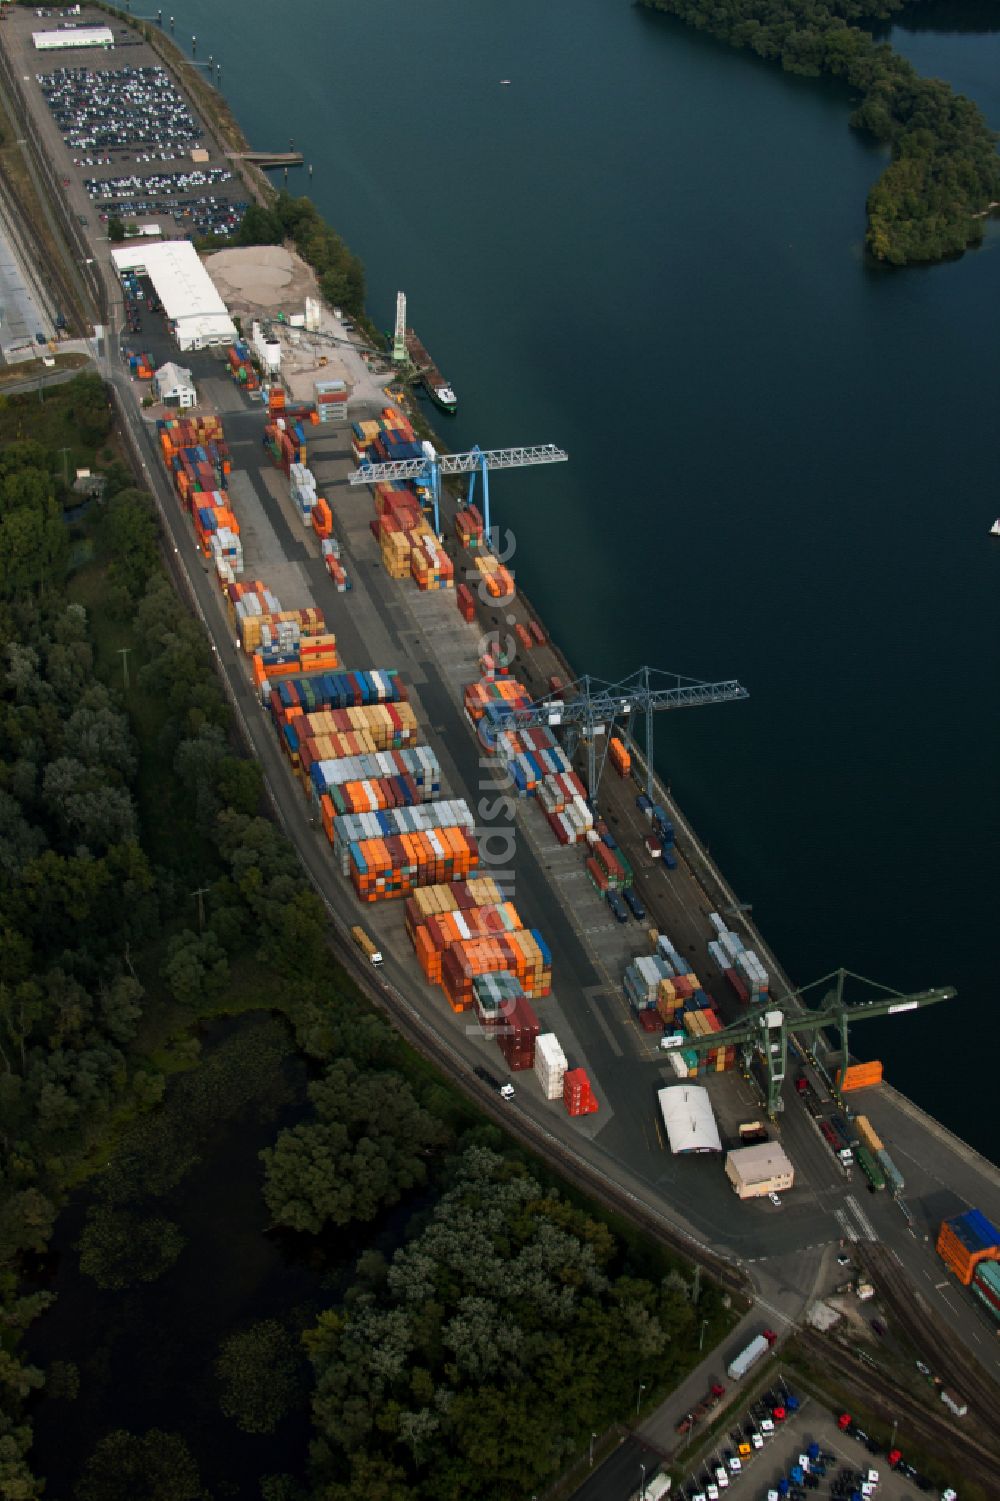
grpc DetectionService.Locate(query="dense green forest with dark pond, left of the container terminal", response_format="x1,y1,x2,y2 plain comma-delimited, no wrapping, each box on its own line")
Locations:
0,377,723,1501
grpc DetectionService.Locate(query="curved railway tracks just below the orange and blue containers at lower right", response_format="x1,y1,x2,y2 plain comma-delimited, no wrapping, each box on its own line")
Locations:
854,1241,1000,1430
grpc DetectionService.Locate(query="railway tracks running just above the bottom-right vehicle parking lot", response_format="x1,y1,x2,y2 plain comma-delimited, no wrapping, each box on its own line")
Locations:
800,1330,1000,1495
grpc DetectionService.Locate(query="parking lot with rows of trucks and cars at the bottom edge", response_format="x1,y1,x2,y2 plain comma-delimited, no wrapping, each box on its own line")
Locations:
674,1387,938,1501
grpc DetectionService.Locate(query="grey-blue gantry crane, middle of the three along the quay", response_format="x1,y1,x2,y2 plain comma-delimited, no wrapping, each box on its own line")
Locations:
486,666,749,797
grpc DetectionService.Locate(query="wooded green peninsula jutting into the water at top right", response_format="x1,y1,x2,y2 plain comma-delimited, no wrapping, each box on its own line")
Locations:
643,0,1000,266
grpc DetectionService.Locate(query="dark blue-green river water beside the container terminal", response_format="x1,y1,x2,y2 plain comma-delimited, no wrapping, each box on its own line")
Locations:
157,0,1000,1156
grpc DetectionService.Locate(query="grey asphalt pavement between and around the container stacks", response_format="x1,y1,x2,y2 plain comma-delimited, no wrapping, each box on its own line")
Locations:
107,292,997,1374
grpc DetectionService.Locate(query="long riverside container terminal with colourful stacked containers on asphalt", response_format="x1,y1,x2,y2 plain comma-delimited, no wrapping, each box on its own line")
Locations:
2,8,1000,1488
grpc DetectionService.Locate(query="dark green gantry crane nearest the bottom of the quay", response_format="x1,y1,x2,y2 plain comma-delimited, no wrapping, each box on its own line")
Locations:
666,970,956,1120
